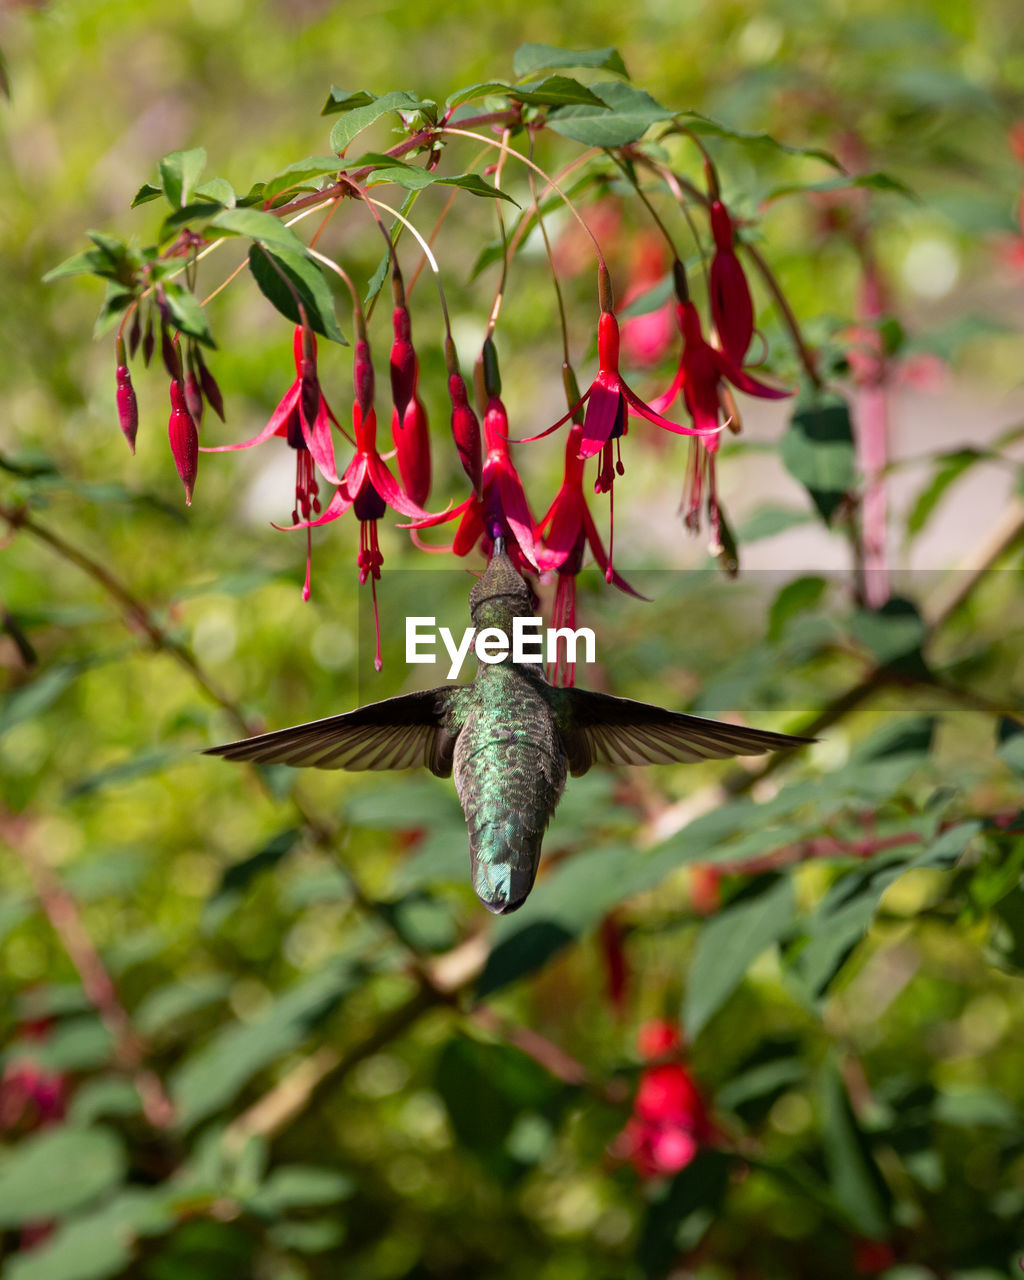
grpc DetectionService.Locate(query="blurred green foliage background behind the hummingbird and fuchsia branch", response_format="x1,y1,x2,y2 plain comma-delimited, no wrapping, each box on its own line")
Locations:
0,0,1024,1280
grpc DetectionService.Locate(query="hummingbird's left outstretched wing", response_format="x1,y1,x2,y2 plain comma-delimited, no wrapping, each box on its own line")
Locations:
205,687,457,778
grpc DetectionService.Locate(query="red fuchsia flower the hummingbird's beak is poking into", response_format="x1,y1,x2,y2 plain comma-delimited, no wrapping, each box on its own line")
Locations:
402,389,539,572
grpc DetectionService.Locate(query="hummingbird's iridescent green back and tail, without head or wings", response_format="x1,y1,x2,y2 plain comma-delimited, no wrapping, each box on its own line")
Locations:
453,664,566,915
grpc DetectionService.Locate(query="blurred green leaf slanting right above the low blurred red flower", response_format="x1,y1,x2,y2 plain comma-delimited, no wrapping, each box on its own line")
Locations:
682,876,796,1041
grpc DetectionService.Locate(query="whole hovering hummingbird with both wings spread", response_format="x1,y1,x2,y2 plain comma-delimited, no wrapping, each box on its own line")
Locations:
206,539,812,915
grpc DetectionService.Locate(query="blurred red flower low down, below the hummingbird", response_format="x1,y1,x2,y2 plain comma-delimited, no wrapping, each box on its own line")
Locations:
616,1020,714,1178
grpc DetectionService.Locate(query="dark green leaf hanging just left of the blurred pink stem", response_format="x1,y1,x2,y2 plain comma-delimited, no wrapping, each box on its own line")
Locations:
780,394,856,524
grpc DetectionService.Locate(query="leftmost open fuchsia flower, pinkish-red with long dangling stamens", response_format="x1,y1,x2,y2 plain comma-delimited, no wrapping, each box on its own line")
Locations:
200,325,340,600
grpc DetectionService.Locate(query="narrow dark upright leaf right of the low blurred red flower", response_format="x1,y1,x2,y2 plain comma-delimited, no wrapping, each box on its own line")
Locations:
822,1060,892,1240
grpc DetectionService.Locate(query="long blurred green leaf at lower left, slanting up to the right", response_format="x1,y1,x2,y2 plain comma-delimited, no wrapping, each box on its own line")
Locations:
170,961,358,1129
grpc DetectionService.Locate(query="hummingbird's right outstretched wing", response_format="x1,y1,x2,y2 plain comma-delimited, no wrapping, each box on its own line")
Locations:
562,689,814,777
